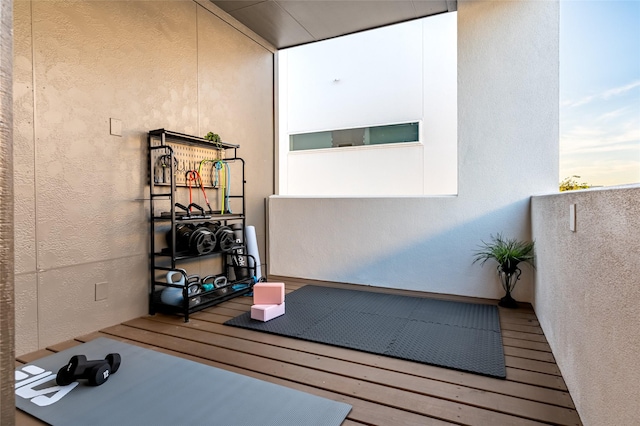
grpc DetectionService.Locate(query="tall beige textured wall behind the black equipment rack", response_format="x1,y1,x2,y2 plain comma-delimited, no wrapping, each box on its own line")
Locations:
14,1,273,354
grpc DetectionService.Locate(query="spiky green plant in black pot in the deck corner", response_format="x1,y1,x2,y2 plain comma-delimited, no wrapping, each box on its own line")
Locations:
473,234,535,308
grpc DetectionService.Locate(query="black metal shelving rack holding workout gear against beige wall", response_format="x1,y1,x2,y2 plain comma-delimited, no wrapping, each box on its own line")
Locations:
148,129,256,322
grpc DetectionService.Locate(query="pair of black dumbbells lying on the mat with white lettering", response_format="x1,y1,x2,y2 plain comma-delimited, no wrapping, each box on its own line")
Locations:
56,353,122,386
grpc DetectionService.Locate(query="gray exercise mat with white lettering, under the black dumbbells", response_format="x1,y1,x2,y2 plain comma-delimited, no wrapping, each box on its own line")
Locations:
15,338,351,426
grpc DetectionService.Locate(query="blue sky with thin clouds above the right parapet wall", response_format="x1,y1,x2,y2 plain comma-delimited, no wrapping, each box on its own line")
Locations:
559,0,640,186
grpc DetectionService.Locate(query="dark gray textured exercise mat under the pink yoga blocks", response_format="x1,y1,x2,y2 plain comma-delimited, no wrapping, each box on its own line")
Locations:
225,285,506,378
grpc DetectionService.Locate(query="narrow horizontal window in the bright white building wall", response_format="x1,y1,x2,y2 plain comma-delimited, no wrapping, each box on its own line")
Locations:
289,122,420,151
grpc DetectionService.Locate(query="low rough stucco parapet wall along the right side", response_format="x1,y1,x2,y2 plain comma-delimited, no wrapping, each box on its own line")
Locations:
532,186,640,426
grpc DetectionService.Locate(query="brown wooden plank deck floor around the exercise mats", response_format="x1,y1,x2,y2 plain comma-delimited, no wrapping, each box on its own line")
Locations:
16,277,581,426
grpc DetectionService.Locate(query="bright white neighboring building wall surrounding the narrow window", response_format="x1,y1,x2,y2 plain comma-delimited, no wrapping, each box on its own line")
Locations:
278,13,457,196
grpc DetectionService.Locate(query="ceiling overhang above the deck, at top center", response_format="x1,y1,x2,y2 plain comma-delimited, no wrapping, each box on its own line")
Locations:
211,0,457,49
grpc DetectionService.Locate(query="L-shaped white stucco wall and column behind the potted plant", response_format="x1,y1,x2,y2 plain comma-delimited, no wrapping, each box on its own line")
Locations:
269,1,558,301
